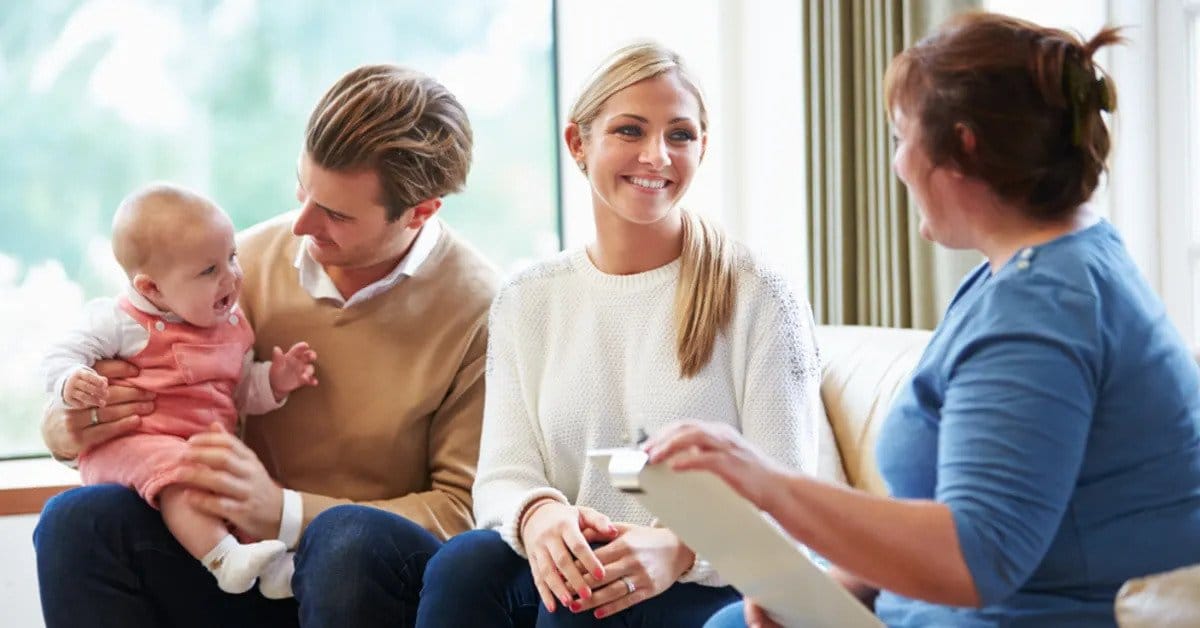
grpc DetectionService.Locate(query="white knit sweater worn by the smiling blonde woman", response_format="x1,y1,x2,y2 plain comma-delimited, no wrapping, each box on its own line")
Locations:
473,249,844,585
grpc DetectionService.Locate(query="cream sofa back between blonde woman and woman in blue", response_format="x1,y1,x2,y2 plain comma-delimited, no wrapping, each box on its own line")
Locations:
816,325,932,495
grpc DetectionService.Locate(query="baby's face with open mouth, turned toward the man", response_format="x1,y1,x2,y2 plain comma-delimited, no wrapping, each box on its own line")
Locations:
154,215,241,327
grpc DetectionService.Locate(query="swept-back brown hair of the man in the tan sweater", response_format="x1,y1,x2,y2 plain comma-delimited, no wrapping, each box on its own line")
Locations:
305,65,473,221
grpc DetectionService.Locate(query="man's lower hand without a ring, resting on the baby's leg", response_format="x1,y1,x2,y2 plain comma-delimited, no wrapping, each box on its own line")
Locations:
180,423,283,539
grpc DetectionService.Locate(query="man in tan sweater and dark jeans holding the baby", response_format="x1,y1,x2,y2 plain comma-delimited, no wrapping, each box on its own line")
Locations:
34,66,497,628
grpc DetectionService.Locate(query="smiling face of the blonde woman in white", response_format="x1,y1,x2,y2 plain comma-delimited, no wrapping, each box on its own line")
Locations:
571,73,707,225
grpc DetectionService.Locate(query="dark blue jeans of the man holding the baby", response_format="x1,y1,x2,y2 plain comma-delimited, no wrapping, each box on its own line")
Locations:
34,485,440,628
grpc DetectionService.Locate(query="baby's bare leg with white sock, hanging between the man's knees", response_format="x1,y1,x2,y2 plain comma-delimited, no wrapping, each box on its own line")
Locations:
158,485,287,593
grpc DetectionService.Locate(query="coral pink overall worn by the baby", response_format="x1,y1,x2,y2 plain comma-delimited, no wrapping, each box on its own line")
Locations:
79,298,254,507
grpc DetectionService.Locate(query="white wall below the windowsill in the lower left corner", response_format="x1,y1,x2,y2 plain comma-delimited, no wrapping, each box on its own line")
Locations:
0,515,46,628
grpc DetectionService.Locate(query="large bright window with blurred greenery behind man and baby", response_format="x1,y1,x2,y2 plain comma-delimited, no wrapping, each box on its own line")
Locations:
0,0,559,457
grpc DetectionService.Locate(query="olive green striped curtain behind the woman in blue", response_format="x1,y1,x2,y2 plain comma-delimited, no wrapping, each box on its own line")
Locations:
800,0,980,329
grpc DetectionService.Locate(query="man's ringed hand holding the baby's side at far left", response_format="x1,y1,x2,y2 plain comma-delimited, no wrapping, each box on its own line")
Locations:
42,360,155,460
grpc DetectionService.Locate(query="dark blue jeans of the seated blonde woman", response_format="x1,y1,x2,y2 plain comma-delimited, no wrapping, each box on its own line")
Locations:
416,530,740,628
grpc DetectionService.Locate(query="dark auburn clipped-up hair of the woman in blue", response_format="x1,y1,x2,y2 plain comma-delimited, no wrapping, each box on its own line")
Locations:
884,12,1122,220
